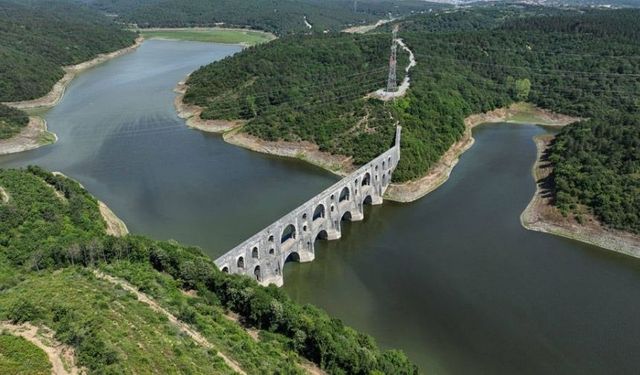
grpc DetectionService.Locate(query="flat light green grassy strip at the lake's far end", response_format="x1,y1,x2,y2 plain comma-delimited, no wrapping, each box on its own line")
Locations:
140,28,274,46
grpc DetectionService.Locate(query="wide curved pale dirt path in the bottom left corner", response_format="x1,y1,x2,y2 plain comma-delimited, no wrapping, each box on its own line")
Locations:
0,322,80,375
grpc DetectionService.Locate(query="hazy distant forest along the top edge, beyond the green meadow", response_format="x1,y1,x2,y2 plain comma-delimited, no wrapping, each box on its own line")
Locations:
84,0,444,35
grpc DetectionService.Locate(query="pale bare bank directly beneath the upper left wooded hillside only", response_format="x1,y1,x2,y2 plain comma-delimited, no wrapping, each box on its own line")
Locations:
3,37,144,109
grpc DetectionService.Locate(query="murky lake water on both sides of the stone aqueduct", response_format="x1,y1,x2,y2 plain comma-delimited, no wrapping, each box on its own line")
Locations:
0,40,640,374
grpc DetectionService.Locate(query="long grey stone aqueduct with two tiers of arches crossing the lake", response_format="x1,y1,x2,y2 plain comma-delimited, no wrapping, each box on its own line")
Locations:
215,126,402,286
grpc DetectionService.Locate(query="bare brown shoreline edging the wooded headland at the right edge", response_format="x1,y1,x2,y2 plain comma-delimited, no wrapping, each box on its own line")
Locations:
520,134,640,258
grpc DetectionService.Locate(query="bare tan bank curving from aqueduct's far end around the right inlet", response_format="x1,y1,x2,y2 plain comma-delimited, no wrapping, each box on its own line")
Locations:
385,103,580,203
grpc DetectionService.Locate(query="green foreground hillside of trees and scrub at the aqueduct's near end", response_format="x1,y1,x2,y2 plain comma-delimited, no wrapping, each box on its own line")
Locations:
0,167,417,374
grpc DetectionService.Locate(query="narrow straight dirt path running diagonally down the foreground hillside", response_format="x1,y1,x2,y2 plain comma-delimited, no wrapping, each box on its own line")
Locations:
94,270,246,375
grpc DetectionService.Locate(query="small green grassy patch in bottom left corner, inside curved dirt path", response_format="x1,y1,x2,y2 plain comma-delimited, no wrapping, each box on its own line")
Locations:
0,333,51,375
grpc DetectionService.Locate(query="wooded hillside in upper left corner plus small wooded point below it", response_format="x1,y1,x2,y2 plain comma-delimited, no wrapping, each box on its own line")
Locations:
0,0,135,139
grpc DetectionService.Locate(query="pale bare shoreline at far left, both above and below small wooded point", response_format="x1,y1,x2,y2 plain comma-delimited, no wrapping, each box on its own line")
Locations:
0,37,144,155
